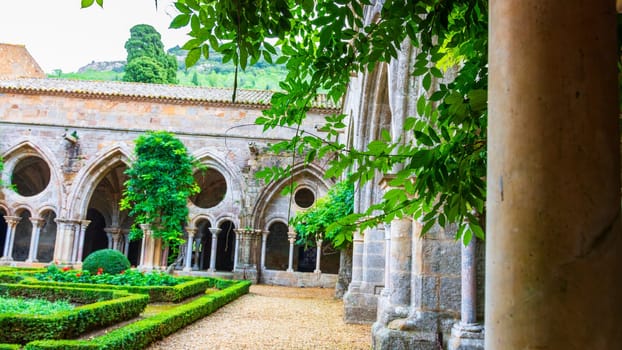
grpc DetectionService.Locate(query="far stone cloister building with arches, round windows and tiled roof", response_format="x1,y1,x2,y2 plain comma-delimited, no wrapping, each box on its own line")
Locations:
0,45,339,287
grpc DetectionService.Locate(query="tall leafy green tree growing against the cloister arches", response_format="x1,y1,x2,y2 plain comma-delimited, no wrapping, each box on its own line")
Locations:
121,131,200,246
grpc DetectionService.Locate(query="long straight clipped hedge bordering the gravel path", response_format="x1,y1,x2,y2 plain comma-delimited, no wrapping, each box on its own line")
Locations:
25,281,251,350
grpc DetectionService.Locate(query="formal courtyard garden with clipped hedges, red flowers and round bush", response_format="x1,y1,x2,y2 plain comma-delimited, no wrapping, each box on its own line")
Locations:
0,250,250,349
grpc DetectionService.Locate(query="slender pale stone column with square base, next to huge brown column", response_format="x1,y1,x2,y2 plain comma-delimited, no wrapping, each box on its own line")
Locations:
448,237,484,350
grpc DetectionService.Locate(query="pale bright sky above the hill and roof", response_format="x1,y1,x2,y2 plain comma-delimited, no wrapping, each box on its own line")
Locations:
0,0,188,73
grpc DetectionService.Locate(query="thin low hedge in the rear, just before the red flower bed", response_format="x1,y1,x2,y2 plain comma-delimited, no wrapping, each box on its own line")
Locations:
21,277,214,303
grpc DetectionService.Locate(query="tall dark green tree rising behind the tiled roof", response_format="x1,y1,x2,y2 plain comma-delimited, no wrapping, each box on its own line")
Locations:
123,24,177,84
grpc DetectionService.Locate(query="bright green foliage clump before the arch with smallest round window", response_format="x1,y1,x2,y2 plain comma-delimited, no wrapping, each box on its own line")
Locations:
290,181,354,249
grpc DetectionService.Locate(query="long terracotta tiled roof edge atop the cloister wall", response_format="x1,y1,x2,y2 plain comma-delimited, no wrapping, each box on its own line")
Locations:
0,78,339,110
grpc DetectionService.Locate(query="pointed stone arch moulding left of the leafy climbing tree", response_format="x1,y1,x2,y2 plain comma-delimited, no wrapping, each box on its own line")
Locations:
65,144,134,220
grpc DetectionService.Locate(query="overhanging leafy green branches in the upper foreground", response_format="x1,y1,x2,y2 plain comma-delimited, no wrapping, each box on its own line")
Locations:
82,0,488,242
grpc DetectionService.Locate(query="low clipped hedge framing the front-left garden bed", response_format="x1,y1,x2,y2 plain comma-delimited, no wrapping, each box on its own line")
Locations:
0,284,149,344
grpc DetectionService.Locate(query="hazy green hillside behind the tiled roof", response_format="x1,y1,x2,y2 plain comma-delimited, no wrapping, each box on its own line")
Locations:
48,47,287,90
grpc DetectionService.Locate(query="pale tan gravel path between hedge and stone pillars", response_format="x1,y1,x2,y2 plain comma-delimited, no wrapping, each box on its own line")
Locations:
148,285,371,350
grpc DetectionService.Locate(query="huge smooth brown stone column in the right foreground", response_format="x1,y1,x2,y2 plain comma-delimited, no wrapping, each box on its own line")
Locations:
485,0,622,349
